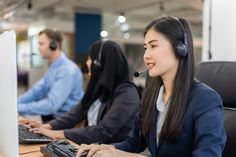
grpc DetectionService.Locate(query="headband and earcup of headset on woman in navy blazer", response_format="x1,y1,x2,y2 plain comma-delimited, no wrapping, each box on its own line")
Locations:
172,16,188,57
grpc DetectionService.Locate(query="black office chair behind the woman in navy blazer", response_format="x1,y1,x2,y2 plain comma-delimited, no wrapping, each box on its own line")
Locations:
195,61,236,157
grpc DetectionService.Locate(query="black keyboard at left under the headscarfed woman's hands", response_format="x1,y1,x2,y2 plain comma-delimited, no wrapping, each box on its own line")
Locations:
18,125,52,144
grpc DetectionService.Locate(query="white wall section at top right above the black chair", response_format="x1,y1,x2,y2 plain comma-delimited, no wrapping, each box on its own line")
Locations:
202,0,236,61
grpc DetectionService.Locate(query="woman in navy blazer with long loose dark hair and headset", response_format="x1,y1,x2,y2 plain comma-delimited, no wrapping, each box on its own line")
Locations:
77,16,226,157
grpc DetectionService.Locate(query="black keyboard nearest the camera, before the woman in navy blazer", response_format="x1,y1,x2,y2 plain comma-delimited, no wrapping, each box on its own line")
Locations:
40,140,87,157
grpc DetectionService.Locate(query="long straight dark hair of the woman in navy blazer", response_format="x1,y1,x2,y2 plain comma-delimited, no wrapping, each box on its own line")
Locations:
142,16,194,143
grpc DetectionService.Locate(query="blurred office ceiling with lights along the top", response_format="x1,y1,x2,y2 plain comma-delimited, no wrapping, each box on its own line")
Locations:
0,0,202,39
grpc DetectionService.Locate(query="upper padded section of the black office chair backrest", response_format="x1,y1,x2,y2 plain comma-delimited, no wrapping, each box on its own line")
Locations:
195,61,236,108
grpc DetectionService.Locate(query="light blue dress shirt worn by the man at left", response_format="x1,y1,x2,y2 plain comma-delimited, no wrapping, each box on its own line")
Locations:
18,53,84,117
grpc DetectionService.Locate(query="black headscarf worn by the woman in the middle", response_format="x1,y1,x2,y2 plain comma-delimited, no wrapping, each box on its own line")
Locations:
81,40,130,113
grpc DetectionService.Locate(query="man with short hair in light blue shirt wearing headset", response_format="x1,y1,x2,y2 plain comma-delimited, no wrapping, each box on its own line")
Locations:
18,29,84,117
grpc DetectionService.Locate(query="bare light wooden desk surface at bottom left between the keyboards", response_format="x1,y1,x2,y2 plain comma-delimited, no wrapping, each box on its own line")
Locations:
19,141,78,157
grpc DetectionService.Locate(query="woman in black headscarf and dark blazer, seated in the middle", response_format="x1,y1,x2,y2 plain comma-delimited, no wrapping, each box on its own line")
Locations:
21,40,140,144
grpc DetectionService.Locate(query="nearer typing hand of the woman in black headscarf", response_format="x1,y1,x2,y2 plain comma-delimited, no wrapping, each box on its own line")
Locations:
29,127,65,139
